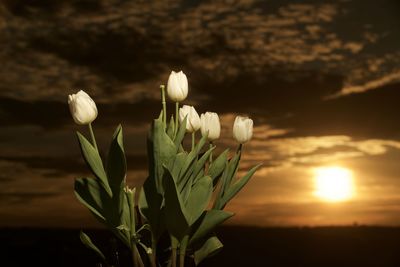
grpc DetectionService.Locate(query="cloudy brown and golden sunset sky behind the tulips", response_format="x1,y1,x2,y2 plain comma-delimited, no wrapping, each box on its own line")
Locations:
0,0,400,227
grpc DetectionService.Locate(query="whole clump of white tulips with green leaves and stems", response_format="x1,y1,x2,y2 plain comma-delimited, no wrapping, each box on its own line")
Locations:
68,71,260,267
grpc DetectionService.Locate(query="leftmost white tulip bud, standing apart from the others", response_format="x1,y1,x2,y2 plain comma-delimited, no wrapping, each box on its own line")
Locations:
68,90,97,125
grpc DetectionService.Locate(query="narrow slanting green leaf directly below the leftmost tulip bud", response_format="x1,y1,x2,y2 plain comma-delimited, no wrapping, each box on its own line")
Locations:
76,132,112,196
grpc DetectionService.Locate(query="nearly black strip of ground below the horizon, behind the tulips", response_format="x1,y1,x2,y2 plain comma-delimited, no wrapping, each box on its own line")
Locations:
0,226,400,267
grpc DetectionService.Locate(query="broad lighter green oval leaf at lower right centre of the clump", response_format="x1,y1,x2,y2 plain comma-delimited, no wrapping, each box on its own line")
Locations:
185,176,213,225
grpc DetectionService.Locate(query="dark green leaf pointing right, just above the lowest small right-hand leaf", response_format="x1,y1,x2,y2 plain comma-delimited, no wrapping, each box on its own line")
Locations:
189,210,234,244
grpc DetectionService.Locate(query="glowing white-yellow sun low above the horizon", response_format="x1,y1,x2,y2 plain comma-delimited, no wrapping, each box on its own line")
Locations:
314,166,354,202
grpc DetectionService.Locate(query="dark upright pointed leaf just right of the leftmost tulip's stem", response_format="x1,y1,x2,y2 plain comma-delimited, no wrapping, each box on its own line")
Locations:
107,125,126,193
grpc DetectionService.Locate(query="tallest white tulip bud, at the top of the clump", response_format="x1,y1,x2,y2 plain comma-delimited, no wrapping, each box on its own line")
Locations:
167,71,188,102
